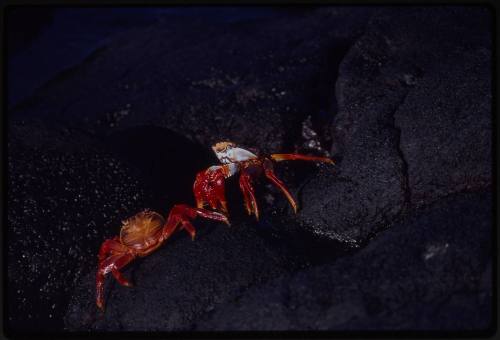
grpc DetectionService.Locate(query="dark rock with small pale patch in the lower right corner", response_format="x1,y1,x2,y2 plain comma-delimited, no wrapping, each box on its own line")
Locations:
196,192,493,331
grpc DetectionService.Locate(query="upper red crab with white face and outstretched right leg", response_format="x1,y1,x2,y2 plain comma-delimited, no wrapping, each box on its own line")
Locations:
193,142,333,220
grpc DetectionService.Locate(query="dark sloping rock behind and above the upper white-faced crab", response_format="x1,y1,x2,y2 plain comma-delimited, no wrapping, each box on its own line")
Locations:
14,8,370,151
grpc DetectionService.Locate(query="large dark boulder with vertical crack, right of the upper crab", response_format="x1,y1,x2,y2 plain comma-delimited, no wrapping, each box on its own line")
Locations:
300,7,492,244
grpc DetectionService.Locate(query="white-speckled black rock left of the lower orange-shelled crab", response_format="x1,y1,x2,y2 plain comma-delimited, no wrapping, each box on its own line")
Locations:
6,120,147,331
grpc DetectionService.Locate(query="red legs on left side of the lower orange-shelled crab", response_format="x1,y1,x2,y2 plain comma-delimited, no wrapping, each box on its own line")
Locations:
96,237,135,310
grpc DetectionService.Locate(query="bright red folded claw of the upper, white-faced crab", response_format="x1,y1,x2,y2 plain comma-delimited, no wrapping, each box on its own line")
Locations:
193,164,238,215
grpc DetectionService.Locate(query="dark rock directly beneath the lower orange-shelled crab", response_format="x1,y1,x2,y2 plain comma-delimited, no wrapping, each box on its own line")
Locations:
65,216,310,331
